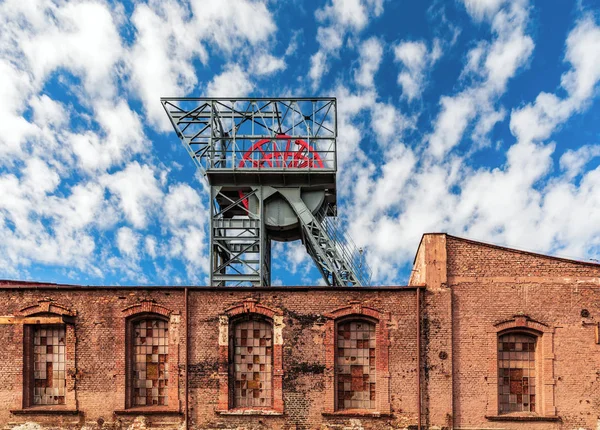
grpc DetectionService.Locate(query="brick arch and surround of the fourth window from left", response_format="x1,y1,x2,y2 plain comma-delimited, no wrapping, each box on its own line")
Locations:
323,302,391,415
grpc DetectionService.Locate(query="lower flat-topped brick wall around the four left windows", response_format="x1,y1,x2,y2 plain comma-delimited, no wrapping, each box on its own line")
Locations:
0,286,417,428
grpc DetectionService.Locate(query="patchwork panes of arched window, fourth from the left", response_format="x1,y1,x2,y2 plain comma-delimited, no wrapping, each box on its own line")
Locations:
336,321,376,410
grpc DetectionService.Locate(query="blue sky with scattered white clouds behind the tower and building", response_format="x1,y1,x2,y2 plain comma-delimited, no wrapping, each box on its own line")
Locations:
0,0,600,285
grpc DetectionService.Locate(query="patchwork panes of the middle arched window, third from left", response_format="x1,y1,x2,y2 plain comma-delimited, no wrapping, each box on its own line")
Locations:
233,319,273,408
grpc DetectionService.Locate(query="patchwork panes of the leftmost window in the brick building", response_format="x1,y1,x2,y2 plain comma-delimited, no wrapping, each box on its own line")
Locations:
33,326,66,405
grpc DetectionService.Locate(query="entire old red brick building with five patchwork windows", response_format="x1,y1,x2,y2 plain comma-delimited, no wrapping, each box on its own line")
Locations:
0,234,600,430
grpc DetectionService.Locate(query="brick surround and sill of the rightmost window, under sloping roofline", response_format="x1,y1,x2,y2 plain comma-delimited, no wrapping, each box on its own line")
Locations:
486,315,560,421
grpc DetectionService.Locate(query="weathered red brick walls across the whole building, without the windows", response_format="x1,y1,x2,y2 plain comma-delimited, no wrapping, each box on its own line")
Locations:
0,234,600,430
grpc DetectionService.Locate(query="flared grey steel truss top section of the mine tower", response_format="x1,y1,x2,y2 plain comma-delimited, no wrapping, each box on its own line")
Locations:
161,97,337,175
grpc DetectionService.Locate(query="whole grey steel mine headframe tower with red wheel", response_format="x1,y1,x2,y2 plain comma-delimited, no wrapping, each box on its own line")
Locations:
161,97,370,286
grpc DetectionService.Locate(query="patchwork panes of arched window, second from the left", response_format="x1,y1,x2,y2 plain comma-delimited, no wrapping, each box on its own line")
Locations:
132,319,169,406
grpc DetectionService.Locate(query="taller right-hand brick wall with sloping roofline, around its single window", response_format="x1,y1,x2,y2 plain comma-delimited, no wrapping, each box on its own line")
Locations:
447,236,600,429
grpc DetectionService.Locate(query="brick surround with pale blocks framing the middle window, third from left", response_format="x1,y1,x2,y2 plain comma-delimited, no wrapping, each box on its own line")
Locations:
216,299,284,415
